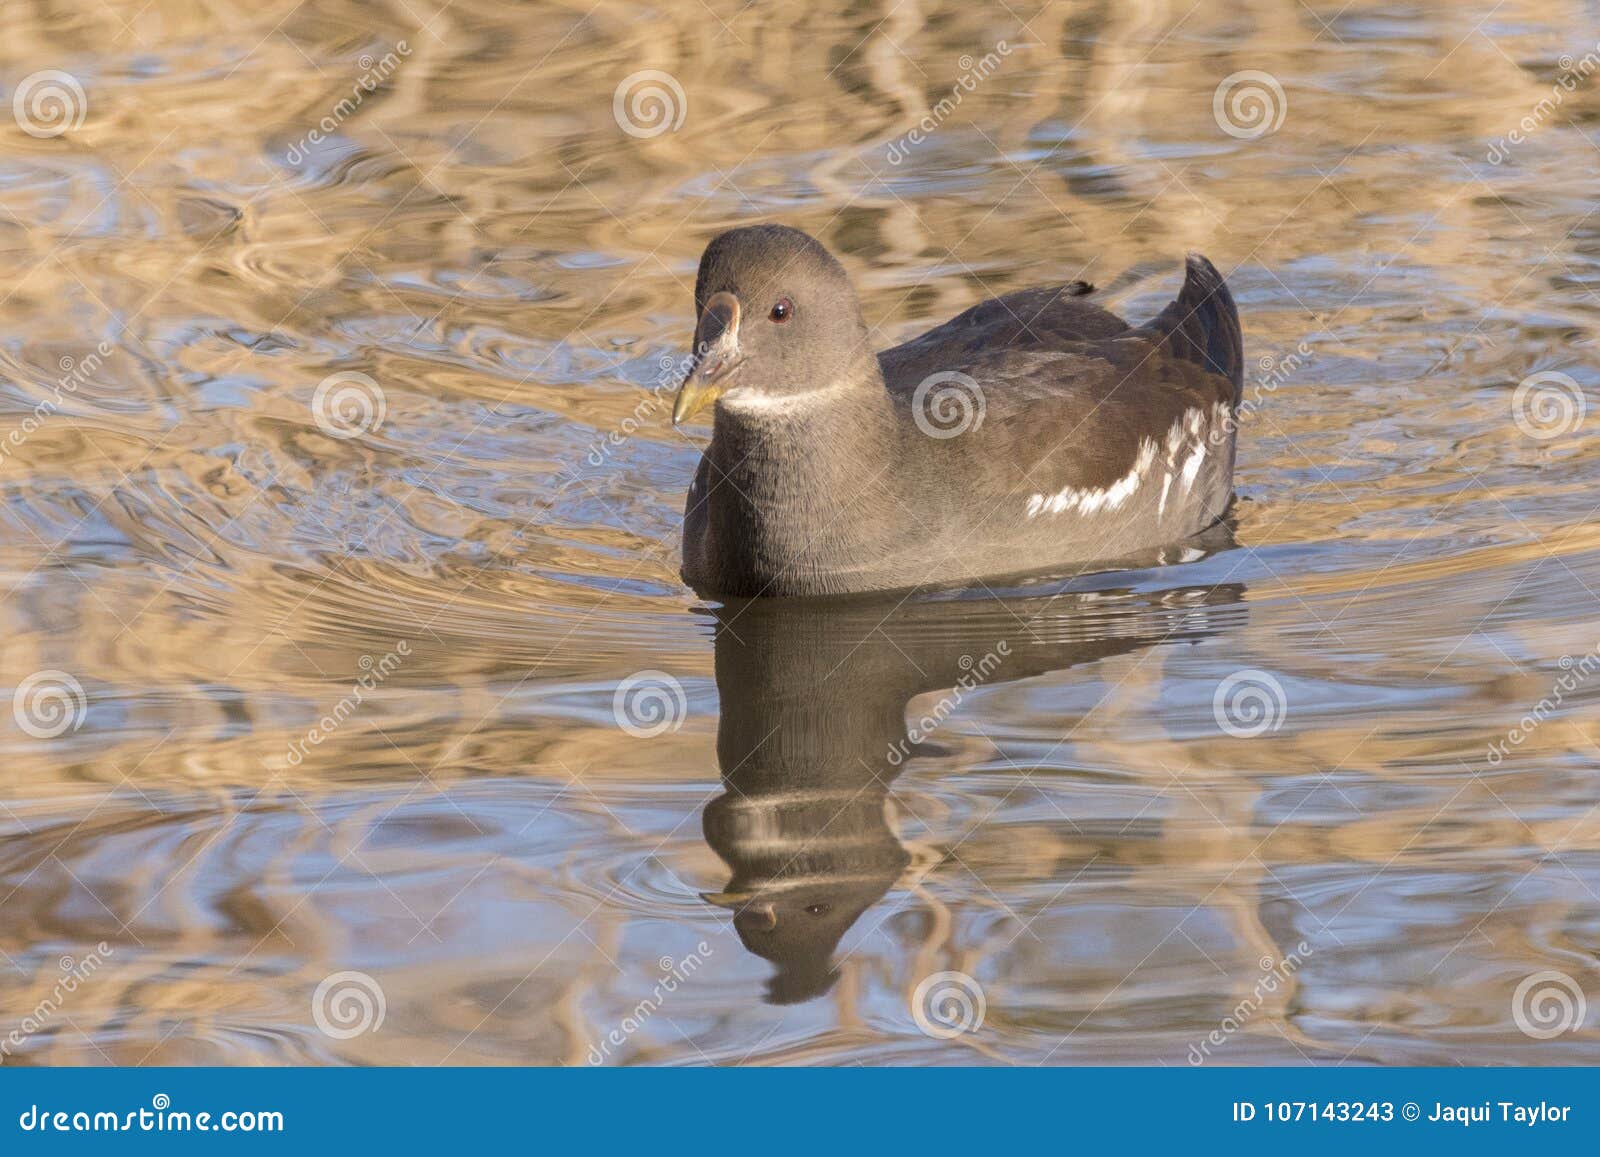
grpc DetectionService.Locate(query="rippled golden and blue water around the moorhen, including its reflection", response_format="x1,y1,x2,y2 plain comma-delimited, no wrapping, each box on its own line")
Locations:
0,0,1600,1066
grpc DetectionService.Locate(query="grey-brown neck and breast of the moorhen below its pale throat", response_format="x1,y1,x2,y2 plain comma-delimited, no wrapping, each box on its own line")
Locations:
707,360,899,594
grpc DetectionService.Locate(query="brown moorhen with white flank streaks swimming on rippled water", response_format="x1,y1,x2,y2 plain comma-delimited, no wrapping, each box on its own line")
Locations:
672,224,1243,597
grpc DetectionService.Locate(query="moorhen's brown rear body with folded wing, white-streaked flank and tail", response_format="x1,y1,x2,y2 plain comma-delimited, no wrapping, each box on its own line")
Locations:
880,256,1243,570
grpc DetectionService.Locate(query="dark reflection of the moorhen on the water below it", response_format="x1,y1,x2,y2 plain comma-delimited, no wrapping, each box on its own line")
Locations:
704,525,1243,1003
